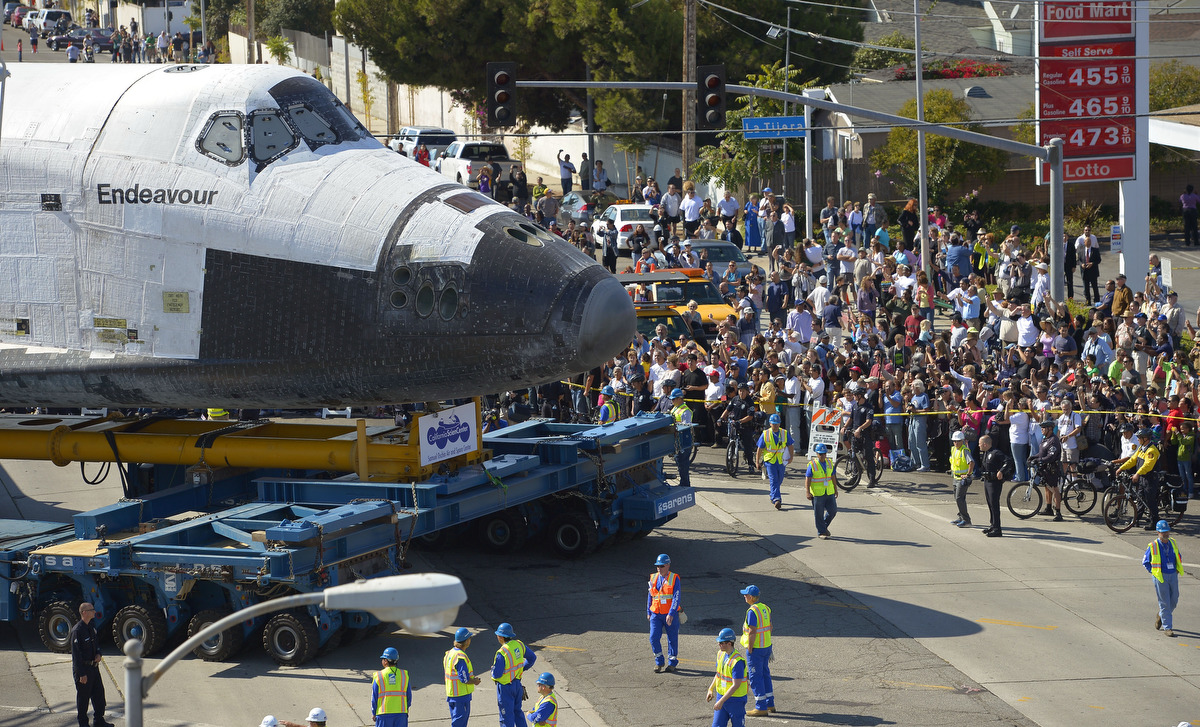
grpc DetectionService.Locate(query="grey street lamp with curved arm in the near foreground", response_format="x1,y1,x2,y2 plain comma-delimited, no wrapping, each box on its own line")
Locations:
124,573,467,727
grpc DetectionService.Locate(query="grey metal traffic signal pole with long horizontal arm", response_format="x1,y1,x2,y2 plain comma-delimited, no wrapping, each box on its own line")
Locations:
516,80,1067,291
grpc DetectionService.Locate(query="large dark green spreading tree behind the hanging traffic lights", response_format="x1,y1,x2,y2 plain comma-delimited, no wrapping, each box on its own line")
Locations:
334,0,862,131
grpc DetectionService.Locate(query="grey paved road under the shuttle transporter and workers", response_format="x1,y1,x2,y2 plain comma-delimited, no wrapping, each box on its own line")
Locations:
0,436,1200,727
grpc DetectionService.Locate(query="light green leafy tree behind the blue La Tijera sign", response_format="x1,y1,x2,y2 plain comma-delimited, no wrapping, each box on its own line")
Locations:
692,61,812,187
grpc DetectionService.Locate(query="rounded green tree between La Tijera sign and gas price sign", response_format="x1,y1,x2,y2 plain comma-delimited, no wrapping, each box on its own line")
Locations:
871,89,1008,202
